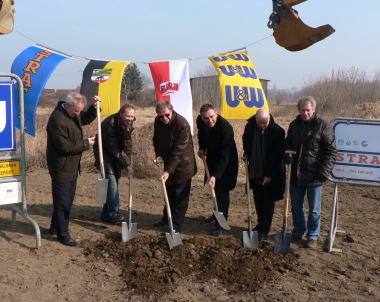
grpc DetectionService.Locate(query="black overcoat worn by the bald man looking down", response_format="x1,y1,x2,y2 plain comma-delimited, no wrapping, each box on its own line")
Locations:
243,115,286,201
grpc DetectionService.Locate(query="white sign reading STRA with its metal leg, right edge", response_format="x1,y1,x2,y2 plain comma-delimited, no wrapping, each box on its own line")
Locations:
328,117,380,252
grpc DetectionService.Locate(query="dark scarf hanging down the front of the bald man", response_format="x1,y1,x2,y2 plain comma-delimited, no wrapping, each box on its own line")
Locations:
249,127,266,185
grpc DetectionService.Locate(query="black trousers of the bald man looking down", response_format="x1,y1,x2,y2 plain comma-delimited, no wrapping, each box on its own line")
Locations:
251,182,275,234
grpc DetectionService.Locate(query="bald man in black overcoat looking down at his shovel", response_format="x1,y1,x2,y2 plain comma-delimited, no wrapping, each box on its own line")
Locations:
243,109,285,240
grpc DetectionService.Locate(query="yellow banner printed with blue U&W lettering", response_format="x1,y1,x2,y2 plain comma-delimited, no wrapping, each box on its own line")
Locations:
210,51,269,119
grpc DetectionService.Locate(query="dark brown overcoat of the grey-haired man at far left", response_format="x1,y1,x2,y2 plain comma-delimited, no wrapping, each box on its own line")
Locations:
46,101,96,182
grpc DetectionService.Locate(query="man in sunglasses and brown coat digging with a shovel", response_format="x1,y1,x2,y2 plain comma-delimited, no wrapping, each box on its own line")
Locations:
153,101,197,232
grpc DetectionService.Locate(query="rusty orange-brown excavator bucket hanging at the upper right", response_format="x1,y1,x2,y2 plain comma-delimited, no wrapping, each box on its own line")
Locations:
273,0,335,51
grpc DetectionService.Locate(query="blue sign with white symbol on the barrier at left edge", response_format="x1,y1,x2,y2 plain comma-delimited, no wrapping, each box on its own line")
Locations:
0,82,16,152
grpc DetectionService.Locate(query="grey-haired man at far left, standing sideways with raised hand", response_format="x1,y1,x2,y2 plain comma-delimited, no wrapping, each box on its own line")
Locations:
46,92,101,246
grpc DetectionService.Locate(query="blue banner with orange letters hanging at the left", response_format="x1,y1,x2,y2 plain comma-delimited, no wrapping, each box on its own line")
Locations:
11,46,68,137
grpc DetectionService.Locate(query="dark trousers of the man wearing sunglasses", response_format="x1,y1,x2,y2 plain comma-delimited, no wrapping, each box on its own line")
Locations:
163,178,191,232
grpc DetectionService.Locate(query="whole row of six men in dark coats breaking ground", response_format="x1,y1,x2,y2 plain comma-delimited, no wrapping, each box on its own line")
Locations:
46,92,336,248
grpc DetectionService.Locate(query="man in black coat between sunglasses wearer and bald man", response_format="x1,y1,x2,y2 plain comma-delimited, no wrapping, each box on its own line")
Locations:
197,104,239,236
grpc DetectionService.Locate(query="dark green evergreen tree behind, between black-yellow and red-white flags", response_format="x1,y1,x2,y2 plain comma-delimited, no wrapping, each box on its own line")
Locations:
121,63,144,101
